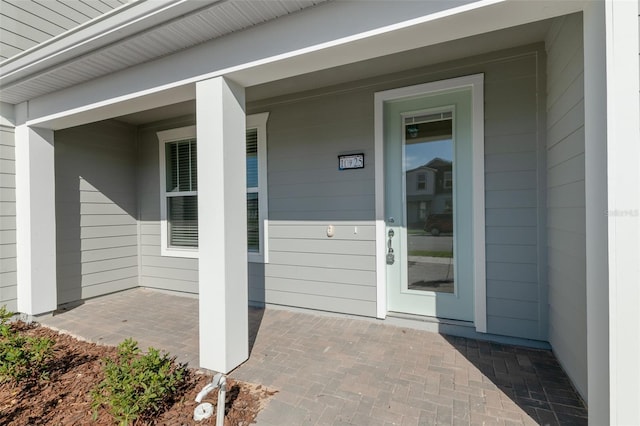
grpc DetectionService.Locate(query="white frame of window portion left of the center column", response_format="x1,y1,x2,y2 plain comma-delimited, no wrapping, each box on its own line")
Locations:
157,126,198,259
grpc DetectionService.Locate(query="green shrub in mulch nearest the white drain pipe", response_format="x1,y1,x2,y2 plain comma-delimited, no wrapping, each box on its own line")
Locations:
91,339,185,425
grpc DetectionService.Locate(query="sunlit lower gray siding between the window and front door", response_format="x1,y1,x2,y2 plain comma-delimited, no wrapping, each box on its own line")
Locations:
264,221,376,316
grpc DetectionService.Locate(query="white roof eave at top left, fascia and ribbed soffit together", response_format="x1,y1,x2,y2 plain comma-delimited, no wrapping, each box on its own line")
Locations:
0,0,328,104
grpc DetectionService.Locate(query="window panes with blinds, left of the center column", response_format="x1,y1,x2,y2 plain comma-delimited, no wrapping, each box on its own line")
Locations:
165,139,198,248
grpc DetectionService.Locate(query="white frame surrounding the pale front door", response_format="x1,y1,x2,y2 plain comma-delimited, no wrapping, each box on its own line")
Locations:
374,74,487,333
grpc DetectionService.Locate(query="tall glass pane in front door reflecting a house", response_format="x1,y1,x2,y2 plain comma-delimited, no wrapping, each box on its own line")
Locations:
403,112,455,293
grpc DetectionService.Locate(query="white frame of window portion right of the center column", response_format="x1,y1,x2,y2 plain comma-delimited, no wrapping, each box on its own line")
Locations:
247,112,269,263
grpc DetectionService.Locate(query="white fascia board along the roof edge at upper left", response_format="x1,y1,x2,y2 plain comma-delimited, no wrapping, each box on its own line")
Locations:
0,0,213,87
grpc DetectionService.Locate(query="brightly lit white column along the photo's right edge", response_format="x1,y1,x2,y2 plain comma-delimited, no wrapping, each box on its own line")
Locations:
605,0,640,425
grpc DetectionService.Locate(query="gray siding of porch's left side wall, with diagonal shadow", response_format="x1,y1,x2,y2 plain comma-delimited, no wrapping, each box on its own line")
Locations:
55,122,139,303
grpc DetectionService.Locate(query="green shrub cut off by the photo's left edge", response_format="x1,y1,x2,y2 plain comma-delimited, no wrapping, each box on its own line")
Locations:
0,306,54,383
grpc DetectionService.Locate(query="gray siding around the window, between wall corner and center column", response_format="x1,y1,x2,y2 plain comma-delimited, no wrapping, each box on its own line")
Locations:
138,117,198,294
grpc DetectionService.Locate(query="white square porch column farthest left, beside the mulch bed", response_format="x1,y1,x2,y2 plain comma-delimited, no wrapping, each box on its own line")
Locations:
15,105,57,315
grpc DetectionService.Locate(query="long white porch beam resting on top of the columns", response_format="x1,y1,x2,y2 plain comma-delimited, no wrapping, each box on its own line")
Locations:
29,0,583,128
